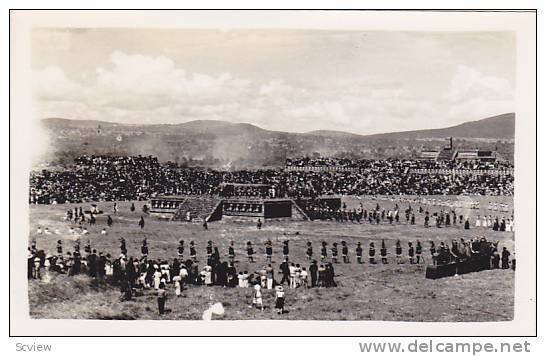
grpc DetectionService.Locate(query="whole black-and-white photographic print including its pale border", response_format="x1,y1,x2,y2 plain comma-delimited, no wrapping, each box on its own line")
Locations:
10,10,536,333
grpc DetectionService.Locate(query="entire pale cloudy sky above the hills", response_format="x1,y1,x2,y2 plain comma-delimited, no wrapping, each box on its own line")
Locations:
32,29,516,134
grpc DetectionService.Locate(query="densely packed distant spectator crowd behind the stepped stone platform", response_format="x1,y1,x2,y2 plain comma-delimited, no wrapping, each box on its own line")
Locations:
29,155,514,204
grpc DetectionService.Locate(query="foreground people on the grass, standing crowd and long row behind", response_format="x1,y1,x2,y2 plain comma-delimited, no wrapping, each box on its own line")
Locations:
28,206,515,314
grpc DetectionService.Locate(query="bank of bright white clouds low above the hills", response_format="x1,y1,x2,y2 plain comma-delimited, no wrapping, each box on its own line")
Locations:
34,51,514,134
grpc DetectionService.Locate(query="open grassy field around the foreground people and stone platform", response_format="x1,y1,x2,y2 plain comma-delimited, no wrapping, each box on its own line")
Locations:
29,197,514,321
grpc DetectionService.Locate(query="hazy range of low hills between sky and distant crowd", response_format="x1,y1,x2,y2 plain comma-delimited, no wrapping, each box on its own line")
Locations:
43,113,515,168
